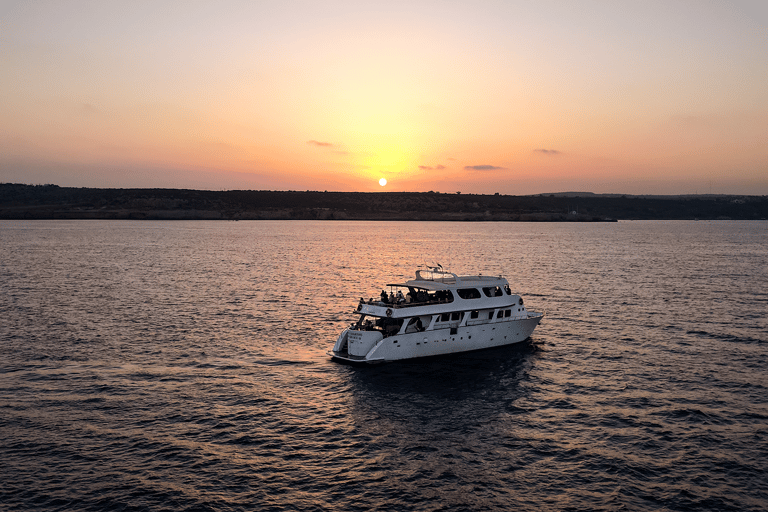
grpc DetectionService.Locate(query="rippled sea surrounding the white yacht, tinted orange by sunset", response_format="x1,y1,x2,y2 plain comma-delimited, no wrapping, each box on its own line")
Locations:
0,221,768,511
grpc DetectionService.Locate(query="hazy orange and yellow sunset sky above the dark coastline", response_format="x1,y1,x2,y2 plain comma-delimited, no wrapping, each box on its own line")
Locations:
0,0,768,195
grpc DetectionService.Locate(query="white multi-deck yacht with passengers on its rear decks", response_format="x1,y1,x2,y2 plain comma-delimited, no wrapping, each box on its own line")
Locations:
328,266,544,363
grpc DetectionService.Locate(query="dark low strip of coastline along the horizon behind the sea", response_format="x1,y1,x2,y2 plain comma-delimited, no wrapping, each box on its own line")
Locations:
0,183,768,222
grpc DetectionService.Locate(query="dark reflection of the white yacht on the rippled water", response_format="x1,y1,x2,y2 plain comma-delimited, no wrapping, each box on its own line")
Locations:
342,342,541,440
